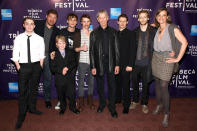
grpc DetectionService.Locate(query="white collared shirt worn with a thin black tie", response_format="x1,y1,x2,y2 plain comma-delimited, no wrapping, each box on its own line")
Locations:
11,32,45,63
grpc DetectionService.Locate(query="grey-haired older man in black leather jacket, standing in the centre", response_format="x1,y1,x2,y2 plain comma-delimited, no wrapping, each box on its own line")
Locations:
90,10,119,118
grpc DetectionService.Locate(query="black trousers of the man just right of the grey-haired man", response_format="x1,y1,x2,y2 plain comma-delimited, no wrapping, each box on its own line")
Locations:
116,69,131,108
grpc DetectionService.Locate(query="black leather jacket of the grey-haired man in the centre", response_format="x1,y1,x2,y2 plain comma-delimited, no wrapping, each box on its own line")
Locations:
90,26,119,76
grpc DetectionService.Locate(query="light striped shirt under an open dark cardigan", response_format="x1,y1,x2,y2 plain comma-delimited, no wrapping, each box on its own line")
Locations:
79,30,90,64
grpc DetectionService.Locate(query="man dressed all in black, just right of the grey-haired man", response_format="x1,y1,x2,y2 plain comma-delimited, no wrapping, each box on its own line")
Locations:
116,14,136,114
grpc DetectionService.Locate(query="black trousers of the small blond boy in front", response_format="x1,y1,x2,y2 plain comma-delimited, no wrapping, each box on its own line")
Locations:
56,76,76,110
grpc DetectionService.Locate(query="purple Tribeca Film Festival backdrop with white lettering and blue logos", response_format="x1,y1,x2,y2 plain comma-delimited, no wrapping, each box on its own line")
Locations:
0,0,197,99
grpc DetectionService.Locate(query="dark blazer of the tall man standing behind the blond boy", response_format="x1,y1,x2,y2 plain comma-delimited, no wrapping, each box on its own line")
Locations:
34,20,60,53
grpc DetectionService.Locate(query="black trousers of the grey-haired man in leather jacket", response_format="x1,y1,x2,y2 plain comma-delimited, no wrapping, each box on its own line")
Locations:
96,66,116,113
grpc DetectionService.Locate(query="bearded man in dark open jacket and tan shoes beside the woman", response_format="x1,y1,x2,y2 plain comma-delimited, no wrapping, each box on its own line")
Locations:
127,10,156,114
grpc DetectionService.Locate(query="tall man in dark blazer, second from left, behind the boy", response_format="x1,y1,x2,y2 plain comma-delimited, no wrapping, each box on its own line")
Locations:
34,9,59,108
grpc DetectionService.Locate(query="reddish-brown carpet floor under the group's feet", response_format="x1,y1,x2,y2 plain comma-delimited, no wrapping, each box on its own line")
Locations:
0,98,197,131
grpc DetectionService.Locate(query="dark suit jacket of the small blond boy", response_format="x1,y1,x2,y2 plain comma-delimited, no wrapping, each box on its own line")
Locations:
50,49,77,85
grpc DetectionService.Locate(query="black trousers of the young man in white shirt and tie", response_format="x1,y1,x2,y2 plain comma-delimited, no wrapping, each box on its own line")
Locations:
18,62,42,119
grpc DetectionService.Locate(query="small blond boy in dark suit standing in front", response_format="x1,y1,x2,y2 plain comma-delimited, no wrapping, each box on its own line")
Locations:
50,35,80,115
